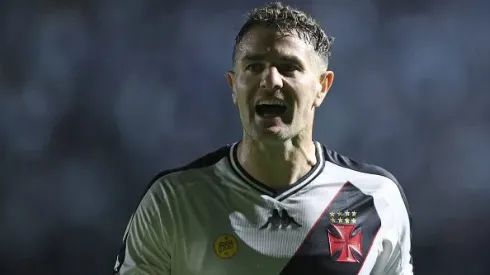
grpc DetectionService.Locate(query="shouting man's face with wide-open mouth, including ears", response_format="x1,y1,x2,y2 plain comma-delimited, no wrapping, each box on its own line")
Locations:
228,27,333,141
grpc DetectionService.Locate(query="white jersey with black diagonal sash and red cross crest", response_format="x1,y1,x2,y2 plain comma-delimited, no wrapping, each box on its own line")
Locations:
115,142,413,275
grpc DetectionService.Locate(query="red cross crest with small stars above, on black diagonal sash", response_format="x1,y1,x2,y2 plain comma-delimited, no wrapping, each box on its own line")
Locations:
327,210,363,263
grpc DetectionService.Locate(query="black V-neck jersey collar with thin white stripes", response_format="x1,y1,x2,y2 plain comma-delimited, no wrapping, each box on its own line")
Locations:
229,141,325,200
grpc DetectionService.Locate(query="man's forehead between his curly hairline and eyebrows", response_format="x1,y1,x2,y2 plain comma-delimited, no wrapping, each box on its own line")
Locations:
237,27,314,61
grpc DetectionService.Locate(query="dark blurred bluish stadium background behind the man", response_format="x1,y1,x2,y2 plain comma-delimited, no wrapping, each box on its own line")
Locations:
0,0,490,275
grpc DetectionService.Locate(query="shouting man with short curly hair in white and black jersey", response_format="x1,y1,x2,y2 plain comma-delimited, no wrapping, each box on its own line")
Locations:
115,3,413,275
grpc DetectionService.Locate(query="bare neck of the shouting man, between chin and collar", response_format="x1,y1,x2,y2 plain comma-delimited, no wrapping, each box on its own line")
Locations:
237,134,317,189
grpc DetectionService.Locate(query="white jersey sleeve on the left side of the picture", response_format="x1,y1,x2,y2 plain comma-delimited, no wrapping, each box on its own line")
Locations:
113,182,171,275
